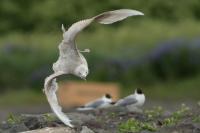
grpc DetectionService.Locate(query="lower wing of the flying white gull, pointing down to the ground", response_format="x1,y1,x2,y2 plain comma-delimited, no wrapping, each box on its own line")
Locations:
44,72,74,127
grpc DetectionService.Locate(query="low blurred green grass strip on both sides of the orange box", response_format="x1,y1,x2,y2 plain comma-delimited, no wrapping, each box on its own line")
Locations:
0,76,200,107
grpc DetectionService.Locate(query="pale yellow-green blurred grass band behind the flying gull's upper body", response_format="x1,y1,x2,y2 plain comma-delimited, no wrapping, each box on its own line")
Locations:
0,19,200,57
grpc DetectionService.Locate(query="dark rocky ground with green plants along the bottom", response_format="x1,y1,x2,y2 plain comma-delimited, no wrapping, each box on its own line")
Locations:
0,101,200,133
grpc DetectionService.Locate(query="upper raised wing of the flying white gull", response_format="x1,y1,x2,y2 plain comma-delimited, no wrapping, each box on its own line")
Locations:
62,9,144,52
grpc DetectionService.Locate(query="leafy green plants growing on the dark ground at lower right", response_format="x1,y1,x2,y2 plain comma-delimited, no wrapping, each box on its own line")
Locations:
118,104,194,133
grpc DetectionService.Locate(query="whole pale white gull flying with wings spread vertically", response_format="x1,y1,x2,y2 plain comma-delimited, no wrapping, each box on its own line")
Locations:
44,9,143,127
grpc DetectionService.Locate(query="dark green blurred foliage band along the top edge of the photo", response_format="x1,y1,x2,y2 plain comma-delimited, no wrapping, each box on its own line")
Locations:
0,0,200,33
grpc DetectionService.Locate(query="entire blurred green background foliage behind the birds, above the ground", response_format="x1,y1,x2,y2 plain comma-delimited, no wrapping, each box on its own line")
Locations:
0,0,200,104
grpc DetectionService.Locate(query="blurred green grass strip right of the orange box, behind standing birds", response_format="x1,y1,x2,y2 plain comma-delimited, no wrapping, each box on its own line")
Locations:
125,76,200,101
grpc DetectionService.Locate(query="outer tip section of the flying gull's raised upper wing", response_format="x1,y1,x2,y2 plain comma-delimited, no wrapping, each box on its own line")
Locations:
94,9,144,24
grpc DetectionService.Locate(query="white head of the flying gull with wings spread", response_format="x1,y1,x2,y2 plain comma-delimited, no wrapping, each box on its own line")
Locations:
75,64,89,80
